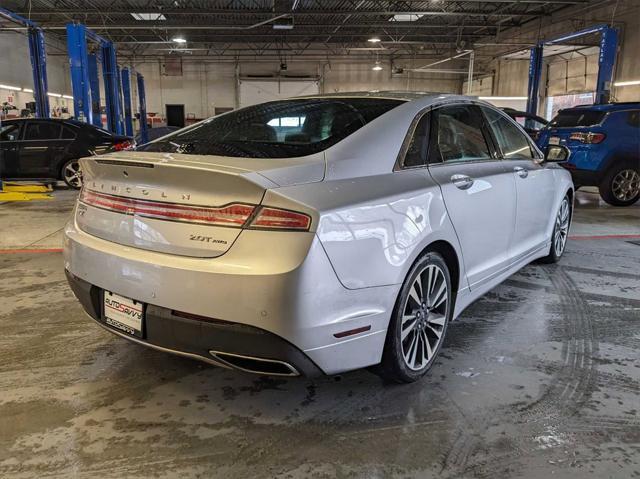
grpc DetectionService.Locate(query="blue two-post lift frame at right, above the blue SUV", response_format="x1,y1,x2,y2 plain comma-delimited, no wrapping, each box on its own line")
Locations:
527,24,618,115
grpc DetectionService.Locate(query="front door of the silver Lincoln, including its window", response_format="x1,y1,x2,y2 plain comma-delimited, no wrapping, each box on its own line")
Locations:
481,106,557,261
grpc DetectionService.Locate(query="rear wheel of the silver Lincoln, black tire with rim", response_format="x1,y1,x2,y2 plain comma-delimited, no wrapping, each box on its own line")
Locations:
375,252,453,383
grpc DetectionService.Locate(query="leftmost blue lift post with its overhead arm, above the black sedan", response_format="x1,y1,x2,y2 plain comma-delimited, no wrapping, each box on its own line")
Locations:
0,7,49,118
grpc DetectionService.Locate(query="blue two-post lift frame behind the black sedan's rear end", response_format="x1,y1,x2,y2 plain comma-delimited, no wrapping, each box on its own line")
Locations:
67,23,124,135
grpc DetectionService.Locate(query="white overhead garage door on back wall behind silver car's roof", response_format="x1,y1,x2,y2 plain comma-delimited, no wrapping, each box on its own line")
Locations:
240,80,320,107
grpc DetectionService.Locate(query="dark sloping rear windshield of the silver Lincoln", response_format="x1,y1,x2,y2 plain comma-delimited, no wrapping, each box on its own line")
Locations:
138,98,403,158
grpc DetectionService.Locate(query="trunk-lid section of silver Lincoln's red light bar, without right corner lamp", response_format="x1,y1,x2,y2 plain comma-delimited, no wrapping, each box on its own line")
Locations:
80,188,255,228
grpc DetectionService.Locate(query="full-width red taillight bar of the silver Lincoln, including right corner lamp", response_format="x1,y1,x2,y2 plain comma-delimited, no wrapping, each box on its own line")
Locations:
79,188,311,231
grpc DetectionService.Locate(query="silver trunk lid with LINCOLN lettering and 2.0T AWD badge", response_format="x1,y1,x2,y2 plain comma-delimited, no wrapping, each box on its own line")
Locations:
76,152,324,257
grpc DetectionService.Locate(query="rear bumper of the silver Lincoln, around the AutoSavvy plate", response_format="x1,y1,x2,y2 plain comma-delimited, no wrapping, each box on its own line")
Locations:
64,220,399,376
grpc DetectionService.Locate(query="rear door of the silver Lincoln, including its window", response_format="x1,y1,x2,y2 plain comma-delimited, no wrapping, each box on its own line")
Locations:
428,104,516,289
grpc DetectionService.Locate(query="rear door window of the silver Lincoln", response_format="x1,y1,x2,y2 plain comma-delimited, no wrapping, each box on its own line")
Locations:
429,105,491,163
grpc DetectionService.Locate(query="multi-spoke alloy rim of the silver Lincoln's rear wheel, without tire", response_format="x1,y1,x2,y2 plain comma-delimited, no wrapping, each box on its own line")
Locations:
400,264,449,371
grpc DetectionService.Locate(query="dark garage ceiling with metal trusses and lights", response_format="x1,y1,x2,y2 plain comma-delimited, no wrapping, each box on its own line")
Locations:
1,0,593,59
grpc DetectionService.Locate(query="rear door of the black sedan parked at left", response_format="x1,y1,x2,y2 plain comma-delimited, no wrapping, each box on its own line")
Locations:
18,120,61,178
